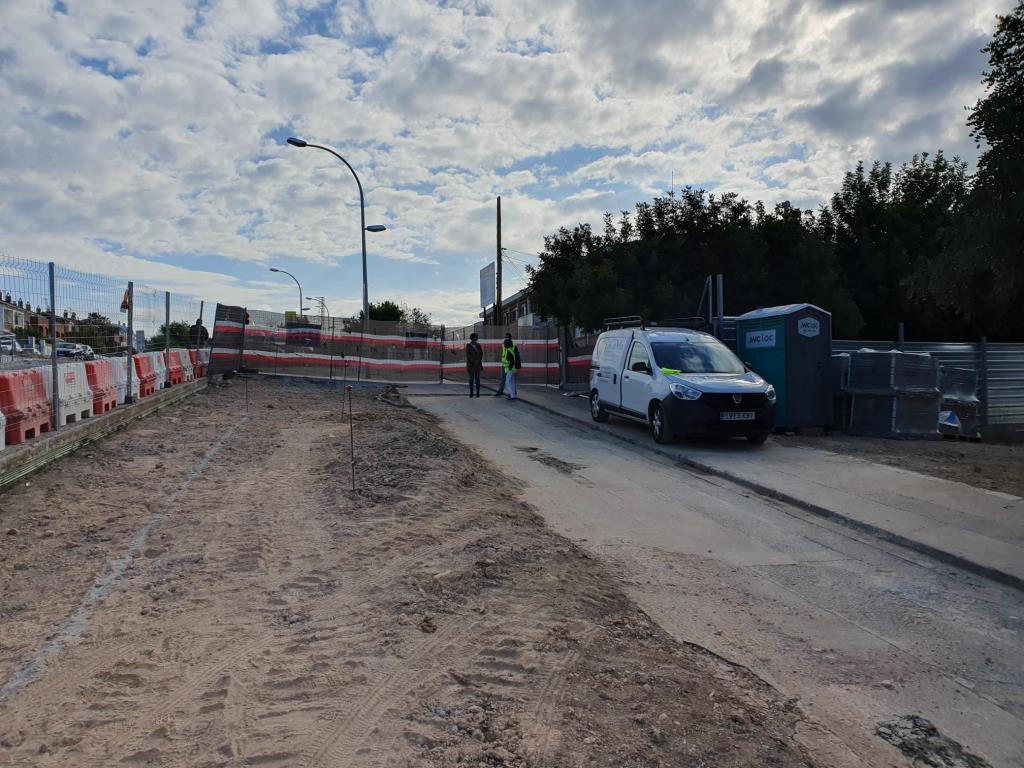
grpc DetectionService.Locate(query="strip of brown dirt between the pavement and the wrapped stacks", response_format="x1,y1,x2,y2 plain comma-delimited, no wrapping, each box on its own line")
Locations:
772,434,1024,497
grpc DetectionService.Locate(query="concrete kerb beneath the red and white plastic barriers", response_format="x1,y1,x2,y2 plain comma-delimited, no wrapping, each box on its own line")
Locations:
0,378,208,492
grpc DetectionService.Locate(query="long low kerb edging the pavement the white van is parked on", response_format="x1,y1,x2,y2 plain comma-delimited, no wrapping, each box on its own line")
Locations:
505,393,1024,591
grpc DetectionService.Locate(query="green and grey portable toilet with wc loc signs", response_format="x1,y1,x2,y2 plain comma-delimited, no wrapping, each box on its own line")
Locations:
736,304,833,429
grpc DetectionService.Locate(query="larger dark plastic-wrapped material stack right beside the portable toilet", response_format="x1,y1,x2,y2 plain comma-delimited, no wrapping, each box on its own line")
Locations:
847,349,941,439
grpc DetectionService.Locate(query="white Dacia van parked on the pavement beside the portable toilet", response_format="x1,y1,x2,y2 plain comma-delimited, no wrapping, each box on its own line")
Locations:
590,327,776,444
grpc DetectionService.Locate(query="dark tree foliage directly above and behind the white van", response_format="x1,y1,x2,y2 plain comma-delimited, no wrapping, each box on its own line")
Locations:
530,188,862,334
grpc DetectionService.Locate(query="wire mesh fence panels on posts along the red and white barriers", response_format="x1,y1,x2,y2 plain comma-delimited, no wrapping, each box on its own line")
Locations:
0,254,216,447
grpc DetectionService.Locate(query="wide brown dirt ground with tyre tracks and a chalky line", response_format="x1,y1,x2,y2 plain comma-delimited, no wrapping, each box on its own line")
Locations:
0,381,810,768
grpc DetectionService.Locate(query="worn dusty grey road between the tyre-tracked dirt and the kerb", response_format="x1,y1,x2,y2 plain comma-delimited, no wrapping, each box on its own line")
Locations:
412,396,1024,767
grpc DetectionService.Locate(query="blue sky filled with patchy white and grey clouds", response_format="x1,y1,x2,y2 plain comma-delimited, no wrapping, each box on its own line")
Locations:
0,0,1013,324
